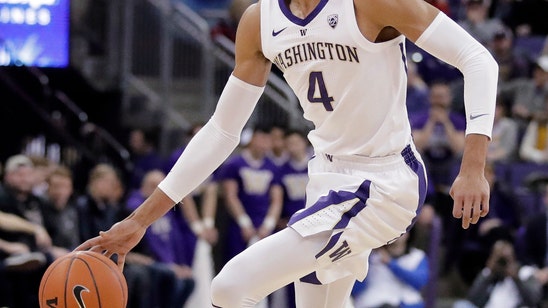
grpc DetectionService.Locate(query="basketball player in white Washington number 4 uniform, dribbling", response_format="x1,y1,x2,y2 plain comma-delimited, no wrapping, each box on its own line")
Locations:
75,0,498,308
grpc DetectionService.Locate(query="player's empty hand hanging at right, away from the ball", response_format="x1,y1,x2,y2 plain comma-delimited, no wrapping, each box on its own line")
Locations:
449,174,489,229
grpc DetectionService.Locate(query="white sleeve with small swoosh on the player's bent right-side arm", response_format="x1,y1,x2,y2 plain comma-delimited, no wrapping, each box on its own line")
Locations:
415,12,498,138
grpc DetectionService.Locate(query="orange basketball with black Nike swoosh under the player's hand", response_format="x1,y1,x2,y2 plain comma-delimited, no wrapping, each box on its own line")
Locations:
38,251,128,308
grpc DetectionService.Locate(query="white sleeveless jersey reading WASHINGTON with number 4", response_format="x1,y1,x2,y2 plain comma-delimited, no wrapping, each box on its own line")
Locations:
260,0,411,157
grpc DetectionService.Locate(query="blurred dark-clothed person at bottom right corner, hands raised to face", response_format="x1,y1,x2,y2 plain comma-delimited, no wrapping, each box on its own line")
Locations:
454,241,541,308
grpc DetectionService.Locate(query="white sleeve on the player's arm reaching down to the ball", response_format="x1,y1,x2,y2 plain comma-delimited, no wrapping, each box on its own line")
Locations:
158,76,264,203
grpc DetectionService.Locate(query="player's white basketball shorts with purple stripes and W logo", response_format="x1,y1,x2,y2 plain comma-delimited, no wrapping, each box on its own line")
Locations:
288,145,427,284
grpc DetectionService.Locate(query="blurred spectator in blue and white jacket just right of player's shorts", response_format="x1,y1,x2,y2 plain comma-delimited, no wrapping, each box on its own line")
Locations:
352,230,429,308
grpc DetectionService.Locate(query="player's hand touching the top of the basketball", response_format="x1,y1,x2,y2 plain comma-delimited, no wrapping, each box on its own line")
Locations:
75,218,146,270
